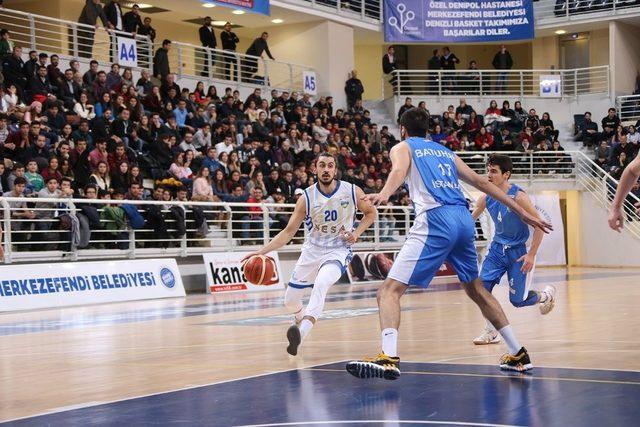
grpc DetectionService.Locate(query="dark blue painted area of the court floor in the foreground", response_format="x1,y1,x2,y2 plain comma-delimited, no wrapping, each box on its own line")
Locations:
8,362,640,427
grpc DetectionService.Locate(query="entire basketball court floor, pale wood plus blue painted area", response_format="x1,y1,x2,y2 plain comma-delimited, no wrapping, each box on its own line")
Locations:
0,268,640,426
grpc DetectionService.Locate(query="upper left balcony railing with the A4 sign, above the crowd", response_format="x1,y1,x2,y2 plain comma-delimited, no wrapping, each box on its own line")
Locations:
0,9,313,91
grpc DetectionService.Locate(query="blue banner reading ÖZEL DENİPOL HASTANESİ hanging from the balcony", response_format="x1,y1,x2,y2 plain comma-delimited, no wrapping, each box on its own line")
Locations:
384,0,535,43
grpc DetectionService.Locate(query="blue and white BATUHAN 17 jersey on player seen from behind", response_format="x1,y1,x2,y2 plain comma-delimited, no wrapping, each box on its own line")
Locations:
406,137,468,216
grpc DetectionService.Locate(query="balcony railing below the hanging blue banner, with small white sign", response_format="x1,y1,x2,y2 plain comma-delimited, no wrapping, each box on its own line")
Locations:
392,65,609,98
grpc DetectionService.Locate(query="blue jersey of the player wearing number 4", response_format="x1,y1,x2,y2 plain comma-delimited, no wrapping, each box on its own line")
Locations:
487,184,529,246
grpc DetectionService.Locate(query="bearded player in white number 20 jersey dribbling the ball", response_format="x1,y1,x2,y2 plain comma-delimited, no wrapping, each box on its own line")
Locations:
243,153,377,356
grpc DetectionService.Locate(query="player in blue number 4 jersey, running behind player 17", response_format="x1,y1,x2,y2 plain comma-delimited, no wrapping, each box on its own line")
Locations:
473,154,556,345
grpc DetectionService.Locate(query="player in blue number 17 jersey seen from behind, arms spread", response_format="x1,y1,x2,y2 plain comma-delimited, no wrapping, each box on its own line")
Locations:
346,108,551,380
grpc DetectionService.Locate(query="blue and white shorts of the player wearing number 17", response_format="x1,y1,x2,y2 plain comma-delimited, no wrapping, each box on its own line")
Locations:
388,205,478,287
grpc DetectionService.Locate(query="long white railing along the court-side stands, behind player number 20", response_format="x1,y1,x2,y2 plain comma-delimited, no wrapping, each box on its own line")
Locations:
0,197,413,263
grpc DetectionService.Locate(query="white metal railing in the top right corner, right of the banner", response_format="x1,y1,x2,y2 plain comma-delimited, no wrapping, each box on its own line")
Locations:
534,0,640,23
